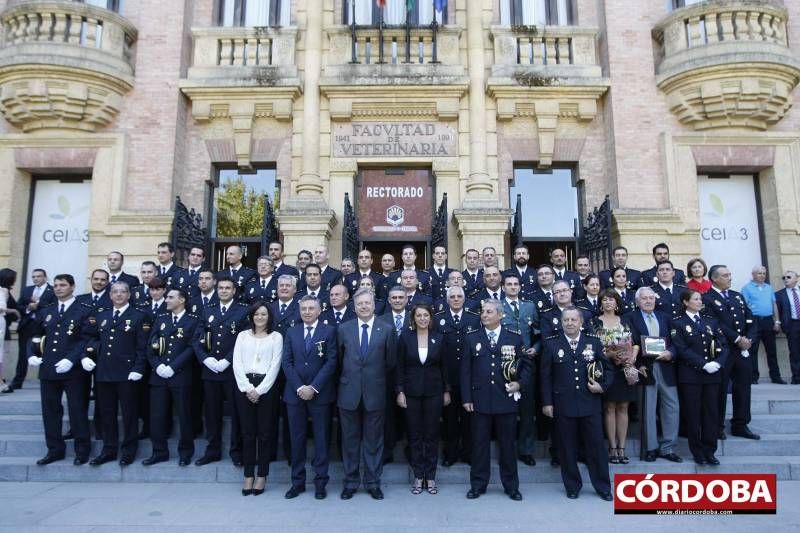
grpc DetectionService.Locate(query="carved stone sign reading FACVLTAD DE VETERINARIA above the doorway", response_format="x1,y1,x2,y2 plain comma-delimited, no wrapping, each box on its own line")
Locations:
332,122,458,158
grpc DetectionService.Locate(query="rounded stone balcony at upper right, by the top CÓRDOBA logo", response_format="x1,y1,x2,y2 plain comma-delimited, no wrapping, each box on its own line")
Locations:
653,0,800,130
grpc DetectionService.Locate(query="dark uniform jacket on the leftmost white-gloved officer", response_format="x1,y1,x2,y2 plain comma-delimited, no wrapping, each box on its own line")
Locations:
28,299,94,380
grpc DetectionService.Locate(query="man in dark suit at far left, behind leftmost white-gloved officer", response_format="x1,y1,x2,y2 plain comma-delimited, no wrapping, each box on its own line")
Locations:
3,268,56,393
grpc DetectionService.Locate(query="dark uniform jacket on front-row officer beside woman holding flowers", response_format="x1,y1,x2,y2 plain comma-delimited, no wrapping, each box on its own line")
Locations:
541,332,614,417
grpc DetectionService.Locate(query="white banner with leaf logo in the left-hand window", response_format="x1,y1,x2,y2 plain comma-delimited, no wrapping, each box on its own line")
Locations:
25,180,92,294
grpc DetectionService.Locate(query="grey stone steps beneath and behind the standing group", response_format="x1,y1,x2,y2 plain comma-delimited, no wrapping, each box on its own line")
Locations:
0,381,800,485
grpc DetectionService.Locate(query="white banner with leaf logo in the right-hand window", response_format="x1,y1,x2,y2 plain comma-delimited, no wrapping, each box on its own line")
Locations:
697,176,763,291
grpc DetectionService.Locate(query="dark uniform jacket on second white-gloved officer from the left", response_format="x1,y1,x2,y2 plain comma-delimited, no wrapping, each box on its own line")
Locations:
86,304,151,382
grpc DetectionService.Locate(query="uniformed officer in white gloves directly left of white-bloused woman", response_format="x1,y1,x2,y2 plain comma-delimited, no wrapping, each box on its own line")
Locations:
193,275,245,466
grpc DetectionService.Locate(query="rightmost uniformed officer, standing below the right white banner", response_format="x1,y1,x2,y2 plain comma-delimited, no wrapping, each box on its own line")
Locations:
703,265,761,440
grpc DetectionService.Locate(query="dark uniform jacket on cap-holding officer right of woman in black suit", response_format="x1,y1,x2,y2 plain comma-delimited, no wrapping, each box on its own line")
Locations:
460,326,531,415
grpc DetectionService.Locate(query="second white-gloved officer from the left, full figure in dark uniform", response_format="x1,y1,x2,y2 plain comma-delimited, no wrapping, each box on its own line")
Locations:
81,281,150,466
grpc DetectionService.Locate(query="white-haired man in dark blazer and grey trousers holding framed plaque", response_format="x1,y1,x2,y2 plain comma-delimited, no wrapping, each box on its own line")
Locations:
628,287,683,463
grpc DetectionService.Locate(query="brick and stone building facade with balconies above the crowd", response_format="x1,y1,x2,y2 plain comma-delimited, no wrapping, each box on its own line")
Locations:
0,0,800,290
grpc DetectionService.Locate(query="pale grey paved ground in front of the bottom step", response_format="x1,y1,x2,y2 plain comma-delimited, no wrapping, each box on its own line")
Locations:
0,482,800,533
